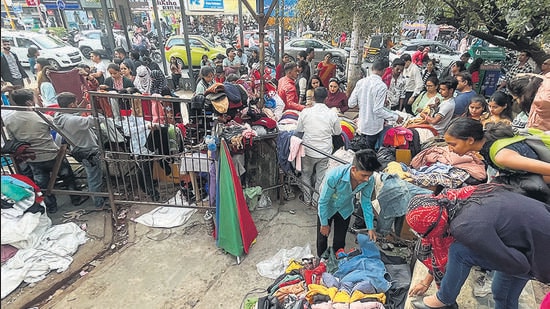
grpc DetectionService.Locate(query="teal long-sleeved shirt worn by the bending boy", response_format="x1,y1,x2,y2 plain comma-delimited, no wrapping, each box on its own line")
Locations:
318,164,374,230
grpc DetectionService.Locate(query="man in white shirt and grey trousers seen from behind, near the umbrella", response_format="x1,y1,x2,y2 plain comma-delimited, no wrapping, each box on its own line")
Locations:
295,87,342,205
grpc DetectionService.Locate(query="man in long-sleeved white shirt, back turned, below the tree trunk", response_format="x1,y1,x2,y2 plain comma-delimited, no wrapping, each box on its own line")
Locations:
348,60,403,149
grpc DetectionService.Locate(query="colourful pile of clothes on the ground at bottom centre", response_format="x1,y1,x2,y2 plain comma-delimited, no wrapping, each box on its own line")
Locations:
252,234,408,309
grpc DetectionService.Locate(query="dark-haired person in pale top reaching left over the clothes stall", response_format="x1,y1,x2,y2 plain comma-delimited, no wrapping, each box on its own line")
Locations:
420,78,457,136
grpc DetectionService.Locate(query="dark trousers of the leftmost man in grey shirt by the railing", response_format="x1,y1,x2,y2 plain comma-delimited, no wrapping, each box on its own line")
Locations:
28,158,80,208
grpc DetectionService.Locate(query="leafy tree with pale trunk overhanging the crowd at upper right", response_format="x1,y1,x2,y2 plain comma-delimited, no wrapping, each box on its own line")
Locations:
297,0,550,91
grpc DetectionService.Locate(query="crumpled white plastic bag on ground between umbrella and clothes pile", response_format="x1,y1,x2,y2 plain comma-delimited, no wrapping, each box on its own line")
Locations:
256,245,311,279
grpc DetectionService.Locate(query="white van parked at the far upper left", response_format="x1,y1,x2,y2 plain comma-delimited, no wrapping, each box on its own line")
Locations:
2,30,83,70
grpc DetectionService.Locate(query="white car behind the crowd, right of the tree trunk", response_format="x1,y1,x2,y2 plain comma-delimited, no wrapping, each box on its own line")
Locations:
389,39,460,68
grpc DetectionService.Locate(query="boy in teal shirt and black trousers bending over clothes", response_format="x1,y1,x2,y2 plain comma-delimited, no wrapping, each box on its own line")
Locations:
317,149,382,256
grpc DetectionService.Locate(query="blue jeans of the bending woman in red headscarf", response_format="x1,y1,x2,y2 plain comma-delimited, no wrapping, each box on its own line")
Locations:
437,242,529,309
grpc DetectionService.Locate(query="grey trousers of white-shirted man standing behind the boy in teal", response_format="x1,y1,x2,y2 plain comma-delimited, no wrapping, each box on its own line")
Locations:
301,156,328,203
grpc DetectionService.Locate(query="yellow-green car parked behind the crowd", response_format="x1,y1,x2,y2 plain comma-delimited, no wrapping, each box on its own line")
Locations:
165,35,225,67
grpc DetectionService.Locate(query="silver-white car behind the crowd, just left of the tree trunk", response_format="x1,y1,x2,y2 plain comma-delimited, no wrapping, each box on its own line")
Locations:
284,38,349,65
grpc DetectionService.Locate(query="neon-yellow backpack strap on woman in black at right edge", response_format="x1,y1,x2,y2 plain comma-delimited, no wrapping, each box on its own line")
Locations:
489,128,550,168
